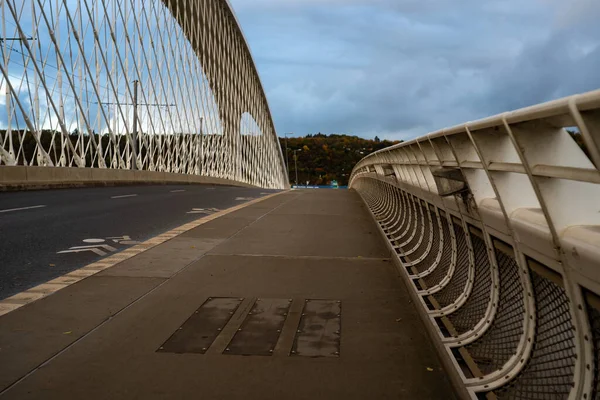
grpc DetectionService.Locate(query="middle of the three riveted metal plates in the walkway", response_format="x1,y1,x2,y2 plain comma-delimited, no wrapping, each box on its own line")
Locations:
223,299,291,356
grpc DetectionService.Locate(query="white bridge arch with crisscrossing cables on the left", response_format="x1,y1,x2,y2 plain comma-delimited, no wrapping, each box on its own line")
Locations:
0,0,288,188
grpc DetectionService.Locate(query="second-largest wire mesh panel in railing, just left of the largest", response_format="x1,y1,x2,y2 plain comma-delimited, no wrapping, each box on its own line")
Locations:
465,244,525,375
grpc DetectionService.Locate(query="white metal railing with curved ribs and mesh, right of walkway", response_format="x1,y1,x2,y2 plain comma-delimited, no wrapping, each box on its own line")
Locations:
350,90,600,399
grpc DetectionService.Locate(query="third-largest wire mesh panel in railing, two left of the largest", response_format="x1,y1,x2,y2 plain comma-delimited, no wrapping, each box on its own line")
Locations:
448,230,492,335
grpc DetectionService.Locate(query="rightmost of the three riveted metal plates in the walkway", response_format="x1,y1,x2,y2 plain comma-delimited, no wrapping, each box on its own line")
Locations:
291,300,342,357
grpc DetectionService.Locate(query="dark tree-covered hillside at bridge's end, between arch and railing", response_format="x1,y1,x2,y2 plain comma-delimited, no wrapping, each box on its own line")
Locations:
279,133,399,186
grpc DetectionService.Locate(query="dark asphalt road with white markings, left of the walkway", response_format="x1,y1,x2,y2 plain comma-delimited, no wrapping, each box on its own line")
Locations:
0,185,274,299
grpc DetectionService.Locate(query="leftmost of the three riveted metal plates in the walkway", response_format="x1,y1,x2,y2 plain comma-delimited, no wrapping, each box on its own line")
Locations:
158,297,243,354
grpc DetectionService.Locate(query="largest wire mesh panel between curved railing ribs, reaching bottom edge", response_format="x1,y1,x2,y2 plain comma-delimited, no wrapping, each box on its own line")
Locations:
495,271,577,399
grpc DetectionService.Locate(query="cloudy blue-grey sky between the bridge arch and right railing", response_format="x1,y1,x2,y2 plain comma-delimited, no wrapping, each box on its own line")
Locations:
231,0,600,139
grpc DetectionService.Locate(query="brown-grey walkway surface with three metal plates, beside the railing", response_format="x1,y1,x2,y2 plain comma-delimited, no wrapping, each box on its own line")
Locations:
0,190,453,400
